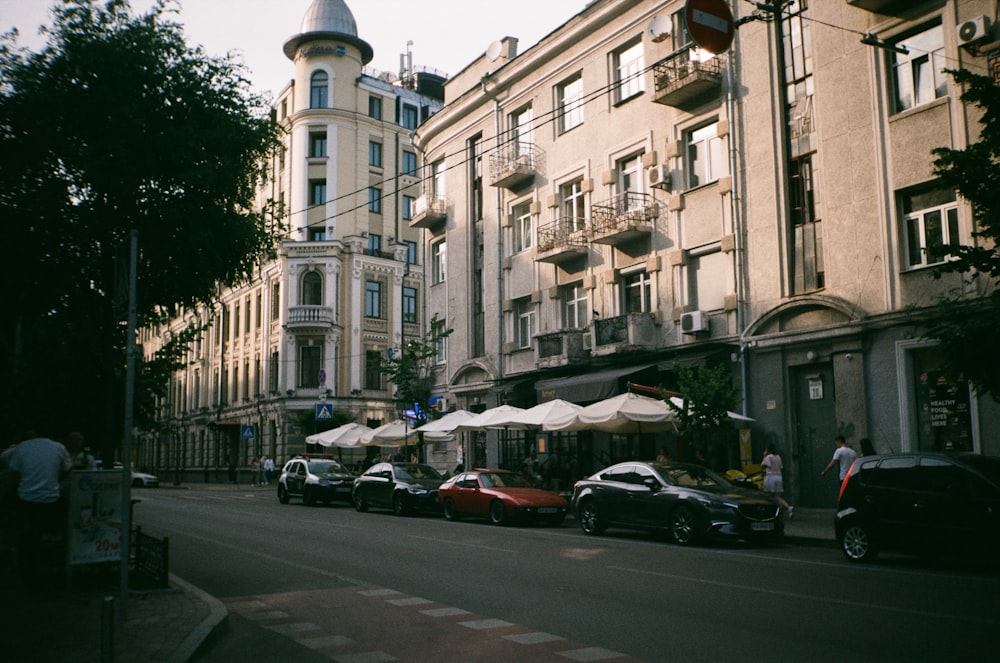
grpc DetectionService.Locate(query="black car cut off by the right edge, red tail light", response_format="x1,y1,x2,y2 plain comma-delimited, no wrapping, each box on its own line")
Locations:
835,453,1000,562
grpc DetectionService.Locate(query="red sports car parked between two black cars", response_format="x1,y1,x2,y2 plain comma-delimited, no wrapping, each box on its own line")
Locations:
438,470,569,526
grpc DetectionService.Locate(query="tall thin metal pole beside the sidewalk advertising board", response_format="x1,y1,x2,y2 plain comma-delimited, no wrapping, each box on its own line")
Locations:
118,229,139,621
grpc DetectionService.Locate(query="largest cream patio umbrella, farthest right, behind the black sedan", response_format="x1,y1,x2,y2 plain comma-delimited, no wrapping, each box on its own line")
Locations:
543,392,680,433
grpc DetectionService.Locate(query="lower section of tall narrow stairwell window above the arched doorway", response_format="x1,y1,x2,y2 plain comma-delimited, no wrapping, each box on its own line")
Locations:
788,155,825,293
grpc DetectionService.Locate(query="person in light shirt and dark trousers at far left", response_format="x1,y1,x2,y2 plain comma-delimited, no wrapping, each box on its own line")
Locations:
6,430,73,585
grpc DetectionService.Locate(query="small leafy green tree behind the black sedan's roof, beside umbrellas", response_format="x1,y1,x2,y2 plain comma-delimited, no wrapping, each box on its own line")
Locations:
663,362,739,467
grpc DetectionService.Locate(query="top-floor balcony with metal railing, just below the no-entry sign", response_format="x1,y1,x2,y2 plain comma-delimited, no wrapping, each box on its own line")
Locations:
653,48,723,109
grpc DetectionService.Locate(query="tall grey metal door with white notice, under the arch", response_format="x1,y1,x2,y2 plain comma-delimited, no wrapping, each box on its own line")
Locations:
785,364,840,508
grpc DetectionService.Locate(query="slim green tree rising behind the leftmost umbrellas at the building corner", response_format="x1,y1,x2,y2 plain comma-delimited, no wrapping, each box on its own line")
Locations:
382,314,454,428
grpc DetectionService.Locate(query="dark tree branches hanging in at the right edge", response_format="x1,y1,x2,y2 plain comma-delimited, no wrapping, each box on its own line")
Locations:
927,69,1000,400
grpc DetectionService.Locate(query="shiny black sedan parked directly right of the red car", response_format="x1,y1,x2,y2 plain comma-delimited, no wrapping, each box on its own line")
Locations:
573,461,784,545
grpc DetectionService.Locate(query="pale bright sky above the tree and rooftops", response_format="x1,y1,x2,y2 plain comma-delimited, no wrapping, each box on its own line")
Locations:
0,0,588,98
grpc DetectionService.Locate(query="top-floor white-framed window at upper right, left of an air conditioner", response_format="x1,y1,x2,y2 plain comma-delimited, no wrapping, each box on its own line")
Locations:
889,25,948,113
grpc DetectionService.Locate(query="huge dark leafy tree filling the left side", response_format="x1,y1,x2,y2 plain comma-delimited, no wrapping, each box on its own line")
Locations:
0,0,283,451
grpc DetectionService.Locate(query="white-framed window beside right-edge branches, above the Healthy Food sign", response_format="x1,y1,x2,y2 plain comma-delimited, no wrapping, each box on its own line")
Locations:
899,187,959,267
